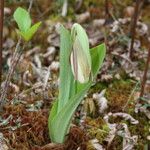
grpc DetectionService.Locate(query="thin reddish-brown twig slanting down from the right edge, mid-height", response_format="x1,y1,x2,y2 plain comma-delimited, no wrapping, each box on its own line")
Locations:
140,47,150,97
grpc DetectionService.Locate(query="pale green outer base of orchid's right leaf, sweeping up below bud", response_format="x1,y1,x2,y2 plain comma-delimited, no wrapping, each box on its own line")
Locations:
49,82,91,143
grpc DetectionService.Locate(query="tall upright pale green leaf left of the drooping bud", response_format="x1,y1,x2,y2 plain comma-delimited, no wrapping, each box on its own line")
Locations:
58,26,74,112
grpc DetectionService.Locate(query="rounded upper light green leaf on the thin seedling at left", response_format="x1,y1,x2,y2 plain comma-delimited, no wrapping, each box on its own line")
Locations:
13,7,31,32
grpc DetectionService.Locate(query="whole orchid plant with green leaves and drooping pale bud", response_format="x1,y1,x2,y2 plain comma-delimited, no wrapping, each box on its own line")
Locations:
48,23,106,143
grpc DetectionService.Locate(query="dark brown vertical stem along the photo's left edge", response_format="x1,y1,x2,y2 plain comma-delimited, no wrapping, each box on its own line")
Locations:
0,0,4,85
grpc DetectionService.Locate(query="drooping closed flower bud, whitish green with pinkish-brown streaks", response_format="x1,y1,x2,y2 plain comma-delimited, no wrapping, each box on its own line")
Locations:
70,23,91,83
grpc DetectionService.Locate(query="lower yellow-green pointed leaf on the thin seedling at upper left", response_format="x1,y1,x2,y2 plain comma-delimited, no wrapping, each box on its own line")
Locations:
19,22,41,41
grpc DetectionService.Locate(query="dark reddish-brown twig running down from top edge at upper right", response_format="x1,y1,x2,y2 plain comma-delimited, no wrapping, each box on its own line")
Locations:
129,0,143,60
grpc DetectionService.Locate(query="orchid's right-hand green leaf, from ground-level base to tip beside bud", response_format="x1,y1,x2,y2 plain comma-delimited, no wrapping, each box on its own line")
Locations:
49,44,106,143
